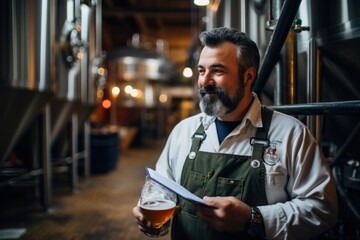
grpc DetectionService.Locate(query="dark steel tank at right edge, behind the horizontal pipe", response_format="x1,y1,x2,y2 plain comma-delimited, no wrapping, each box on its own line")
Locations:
298,0,360,157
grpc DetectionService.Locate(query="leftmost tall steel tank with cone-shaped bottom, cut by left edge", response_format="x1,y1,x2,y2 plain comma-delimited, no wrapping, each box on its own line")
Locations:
0,0,54,163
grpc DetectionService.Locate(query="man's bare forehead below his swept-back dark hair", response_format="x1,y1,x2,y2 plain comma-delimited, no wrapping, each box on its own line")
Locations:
199,42,237,67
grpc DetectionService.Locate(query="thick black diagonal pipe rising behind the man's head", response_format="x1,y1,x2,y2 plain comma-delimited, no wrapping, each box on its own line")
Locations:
253,0,301,94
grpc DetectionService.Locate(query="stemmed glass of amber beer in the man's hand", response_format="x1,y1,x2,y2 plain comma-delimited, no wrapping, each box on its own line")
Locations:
140,176,177,237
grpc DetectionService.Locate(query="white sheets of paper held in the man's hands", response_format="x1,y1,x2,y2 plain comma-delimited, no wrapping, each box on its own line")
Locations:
146,168,206,205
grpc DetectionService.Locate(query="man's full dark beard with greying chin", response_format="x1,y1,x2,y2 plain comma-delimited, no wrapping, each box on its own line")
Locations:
199,88,244,117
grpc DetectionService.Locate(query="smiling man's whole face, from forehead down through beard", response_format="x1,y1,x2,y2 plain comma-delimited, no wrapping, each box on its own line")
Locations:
198,42,244,117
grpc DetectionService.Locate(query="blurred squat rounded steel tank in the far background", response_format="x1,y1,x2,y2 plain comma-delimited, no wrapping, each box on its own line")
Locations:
106,46,174,107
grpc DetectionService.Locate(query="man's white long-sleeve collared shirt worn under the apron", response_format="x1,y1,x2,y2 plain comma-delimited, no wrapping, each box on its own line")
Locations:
156,94,338,239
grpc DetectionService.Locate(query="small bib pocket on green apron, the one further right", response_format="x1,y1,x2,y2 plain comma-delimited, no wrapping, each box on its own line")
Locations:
216,177,244,199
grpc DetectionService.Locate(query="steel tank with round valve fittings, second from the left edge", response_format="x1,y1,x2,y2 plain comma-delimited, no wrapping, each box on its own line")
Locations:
51,0,96,156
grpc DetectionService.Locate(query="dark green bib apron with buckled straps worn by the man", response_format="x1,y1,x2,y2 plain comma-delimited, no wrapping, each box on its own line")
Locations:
171,107,273,240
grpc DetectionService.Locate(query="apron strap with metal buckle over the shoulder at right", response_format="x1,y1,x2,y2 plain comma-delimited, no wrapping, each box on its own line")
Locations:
250,106,274,161
